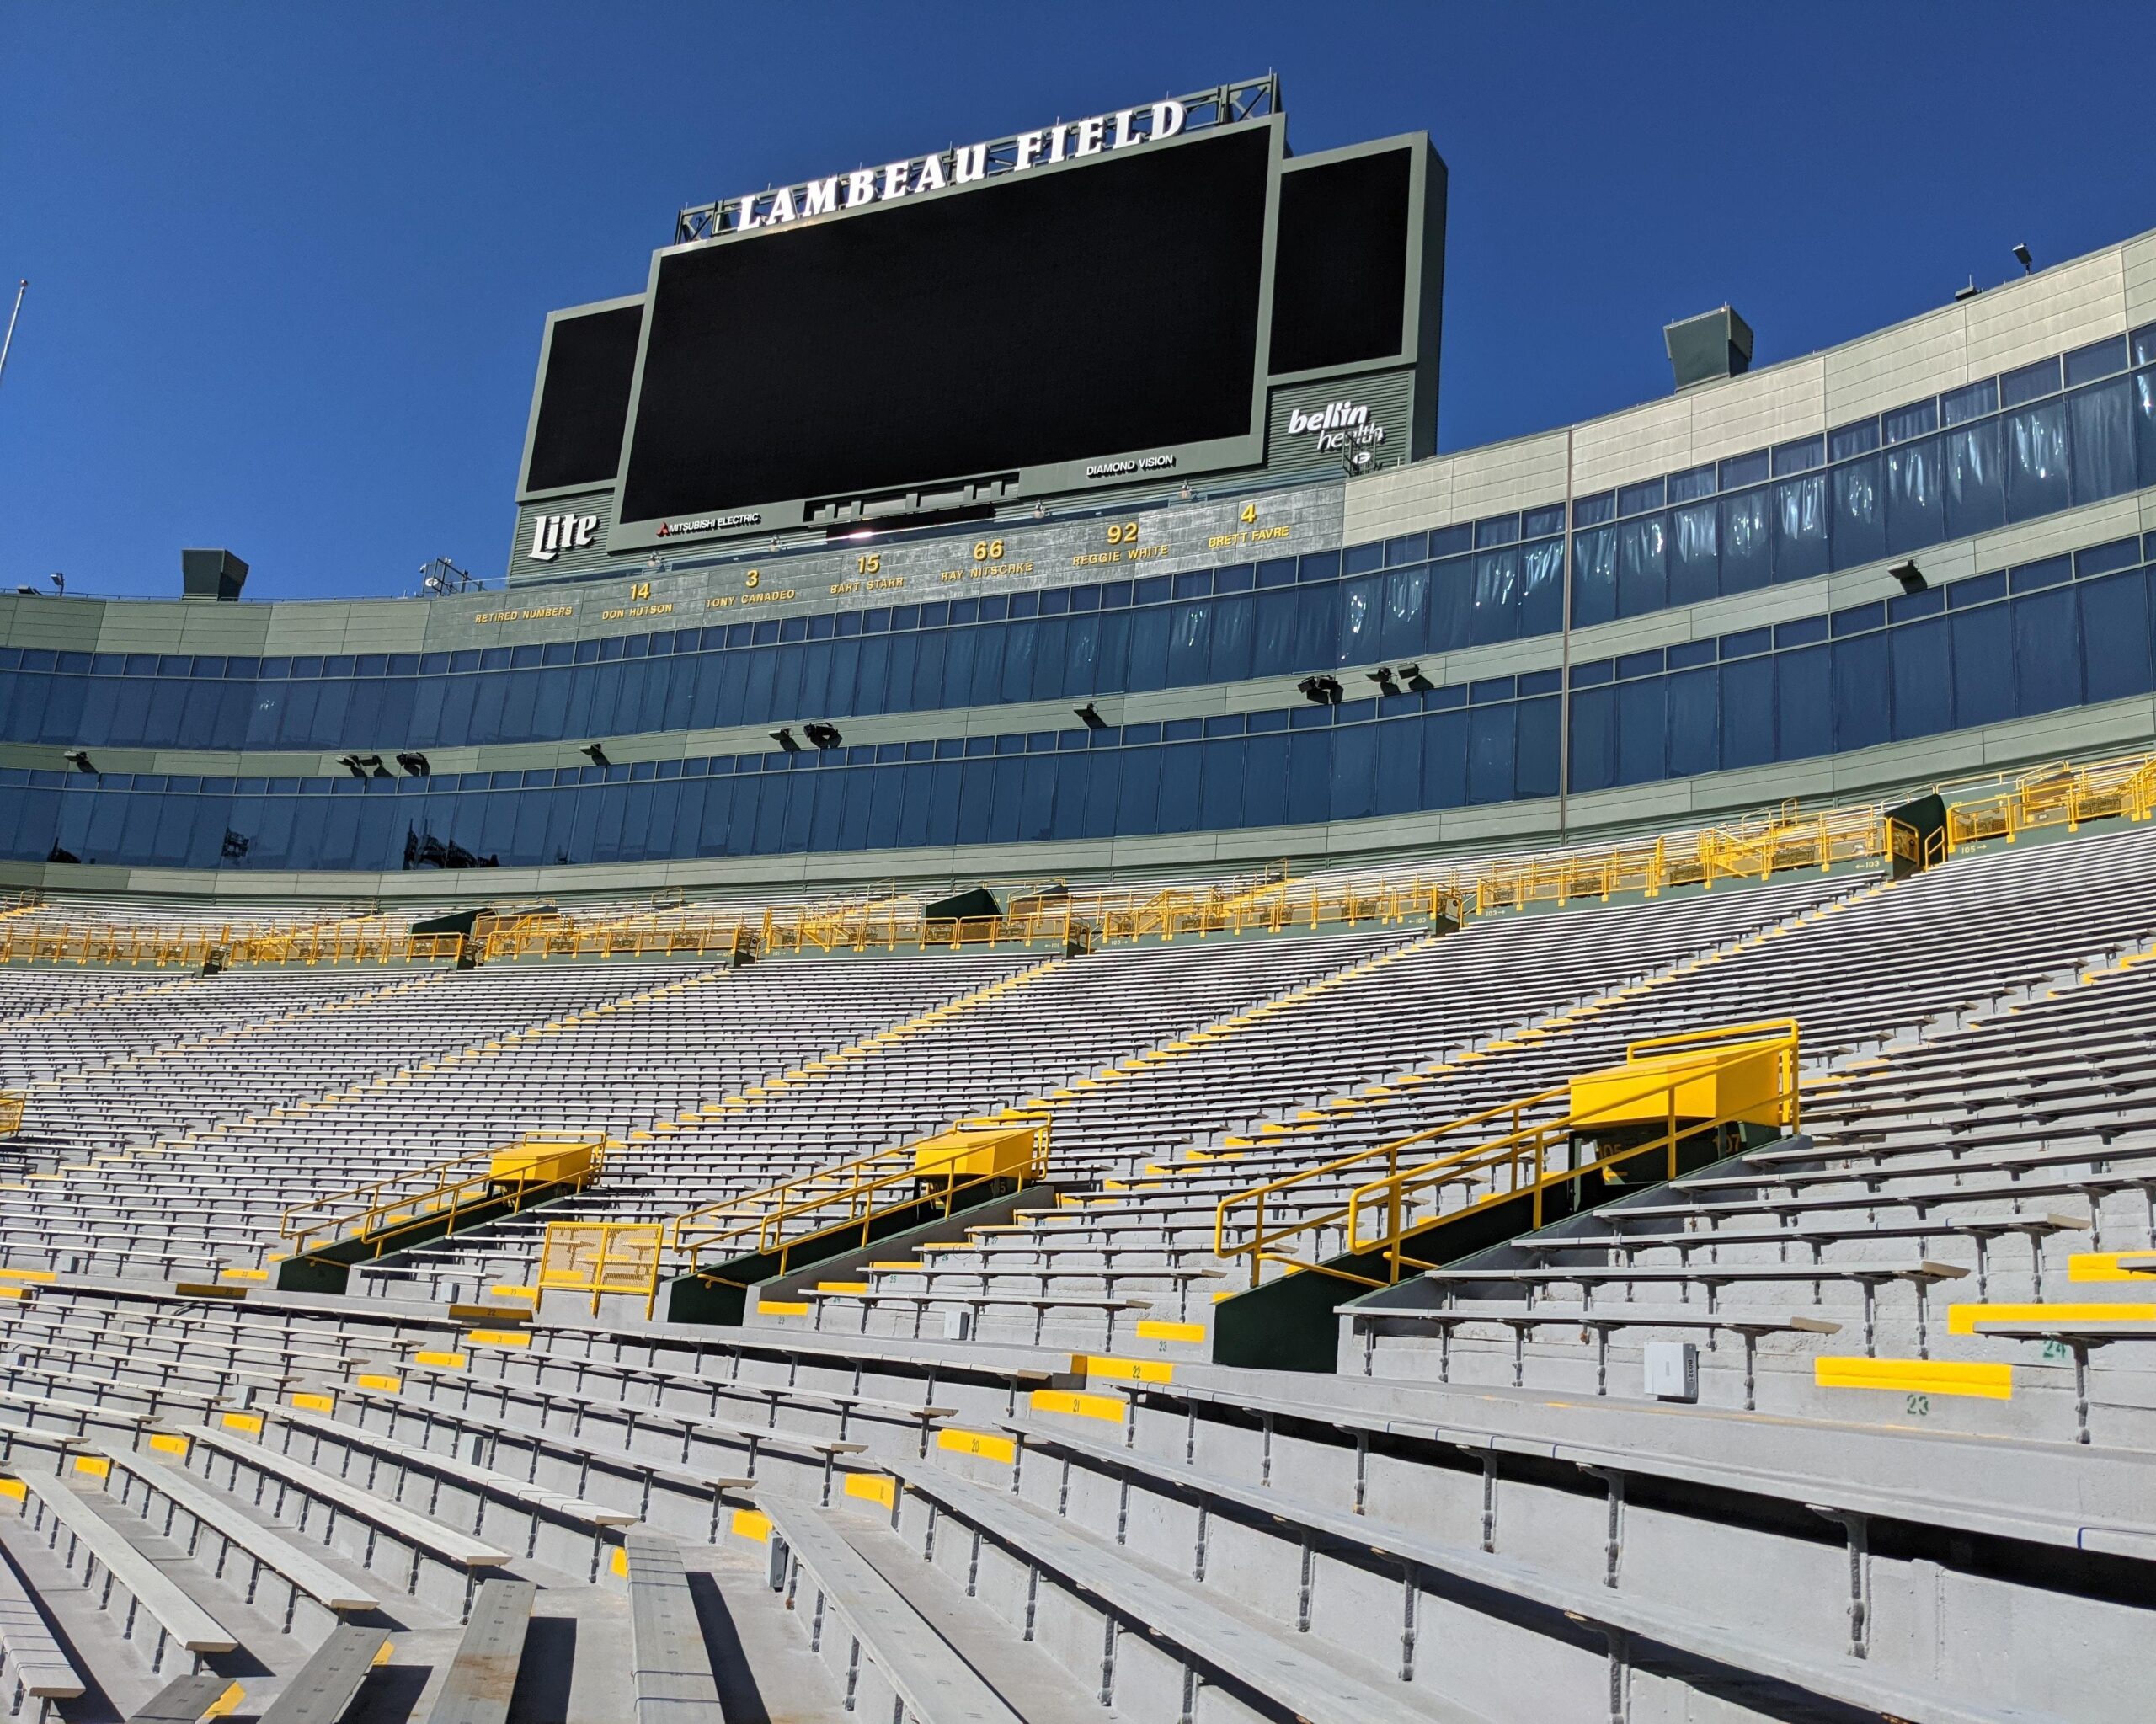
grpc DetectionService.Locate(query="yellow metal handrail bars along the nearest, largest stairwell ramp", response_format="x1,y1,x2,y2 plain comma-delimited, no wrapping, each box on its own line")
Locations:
1214,1019,1801,1287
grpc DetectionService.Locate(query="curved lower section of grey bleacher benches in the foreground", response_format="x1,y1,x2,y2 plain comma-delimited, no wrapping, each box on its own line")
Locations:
0,1282,2156,1724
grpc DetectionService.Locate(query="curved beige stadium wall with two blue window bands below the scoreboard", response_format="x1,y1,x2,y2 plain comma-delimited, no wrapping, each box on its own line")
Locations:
13,224,2156,896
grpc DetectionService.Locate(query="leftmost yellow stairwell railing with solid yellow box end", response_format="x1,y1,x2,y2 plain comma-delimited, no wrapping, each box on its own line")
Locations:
278,1135,608,1257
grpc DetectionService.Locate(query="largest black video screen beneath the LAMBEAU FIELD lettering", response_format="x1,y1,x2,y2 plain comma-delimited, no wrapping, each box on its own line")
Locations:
621,125,1272,521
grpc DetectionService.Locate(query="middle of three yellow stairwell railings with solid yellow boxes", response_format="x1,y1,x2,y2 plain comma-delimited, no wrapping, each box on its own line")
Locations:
669,1114,1048,1273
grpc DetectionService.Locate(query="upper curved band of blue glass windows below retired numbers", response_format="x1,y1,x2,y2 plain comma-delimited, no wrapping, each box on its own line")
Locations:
0,328,2156,750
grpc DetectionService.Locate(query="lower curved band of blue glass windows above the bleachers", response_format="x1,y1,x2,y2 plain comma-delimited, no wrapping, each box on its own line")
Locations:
13,535,2156,871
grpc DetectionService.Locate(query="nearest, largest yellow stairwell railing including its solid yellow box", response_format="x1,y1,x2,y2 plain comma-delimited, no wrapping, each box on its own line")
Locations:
1214,1019,1798,1287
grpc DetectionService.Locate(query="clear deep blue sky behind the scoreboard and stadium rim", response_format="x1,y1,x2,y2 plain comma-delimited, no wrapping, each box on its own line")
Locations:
0,0,2156,599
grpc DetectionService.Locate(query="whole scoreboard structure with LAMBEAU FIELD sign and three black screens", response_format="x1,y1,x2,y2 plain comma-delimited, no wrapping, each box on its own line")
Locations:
509,77,1444,582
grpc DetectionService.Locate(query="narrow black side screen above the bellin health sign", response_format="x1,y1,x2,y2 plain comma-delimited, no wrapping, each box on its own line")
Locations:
1272,149,1412,375
